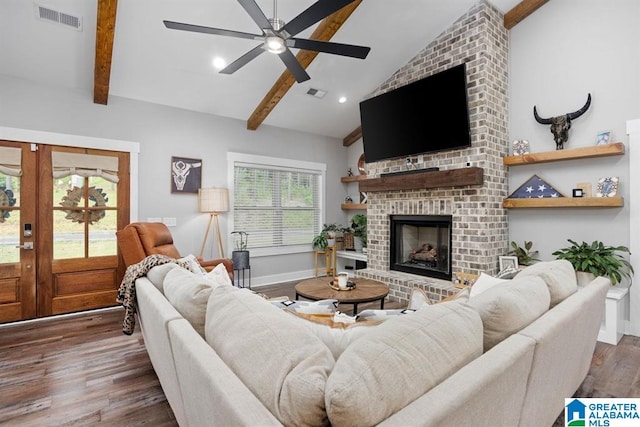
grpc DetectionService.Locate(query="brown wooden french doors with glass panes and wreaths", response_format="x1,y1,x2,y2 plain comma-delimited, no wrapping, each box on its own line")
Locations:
0,141,129,322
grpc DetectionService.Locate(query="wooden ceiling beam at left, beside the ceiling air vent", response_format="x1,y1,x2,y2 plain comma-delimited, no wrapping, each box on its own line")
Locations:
93,0,118,105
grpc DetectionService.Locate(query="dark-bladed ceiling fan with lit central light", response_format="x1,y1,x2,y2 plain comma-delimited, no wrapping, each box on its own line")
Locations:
163,0,371,83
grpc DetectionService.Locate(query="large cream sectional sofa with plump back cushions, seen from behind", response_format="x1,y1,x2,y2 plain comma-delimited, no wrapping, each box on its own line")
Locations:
131,261,611,427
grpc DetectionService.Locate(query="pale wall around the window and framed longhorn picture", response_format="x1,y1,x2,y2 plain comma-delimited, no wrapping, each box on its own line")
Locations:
0,76,347,285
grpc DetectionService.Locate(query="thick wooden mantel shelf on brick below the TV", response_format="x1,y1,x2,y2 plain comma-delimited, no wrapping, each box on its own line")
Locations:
360,167,484,192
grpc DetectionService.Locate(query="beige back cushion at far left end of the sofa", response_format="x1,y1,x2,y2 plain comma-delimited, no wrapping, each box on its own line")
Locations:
163,268,217,337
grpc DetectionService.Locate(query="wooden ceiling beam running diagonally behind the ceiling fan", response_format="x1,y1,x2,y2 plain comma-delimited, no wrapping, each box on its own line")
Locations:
247,0,362,130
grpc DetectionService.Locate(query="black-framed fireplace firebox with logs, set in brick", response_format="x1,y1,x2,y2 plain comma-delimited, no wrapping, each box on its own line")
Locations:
389,215,451,280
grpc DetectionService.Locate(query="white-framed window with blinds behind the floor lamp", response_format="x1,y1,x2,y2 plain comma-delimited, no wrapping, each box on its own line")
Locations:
228,153,326,256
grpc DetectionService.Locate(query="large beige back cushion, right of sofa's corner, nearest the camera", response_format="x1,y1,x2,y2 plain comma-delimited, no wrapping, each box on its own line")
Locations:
325,302,482,426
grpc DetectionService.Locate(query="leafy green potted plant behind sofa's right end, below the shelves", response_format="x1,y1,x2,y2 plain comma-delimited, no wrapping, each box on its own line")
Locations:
553,239,634,285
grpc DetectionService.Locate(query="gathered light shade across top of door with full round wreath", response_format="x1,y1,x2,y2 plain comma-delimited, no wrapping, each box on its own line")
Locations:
51,151,118,183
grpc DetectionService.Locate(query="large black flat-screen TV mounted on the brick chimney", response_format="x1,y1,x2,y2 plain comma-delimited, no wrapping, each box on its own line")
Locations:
360,64,471,163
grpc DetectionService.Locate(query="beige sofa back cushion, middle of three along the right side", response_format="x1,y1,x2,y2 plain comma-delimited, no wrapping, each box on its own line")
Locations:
467,275,550,351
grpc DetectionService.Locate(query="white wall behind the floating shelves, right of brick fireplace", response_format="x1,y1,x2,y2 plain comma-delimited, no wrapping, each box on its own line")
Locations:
509,0,640,268
